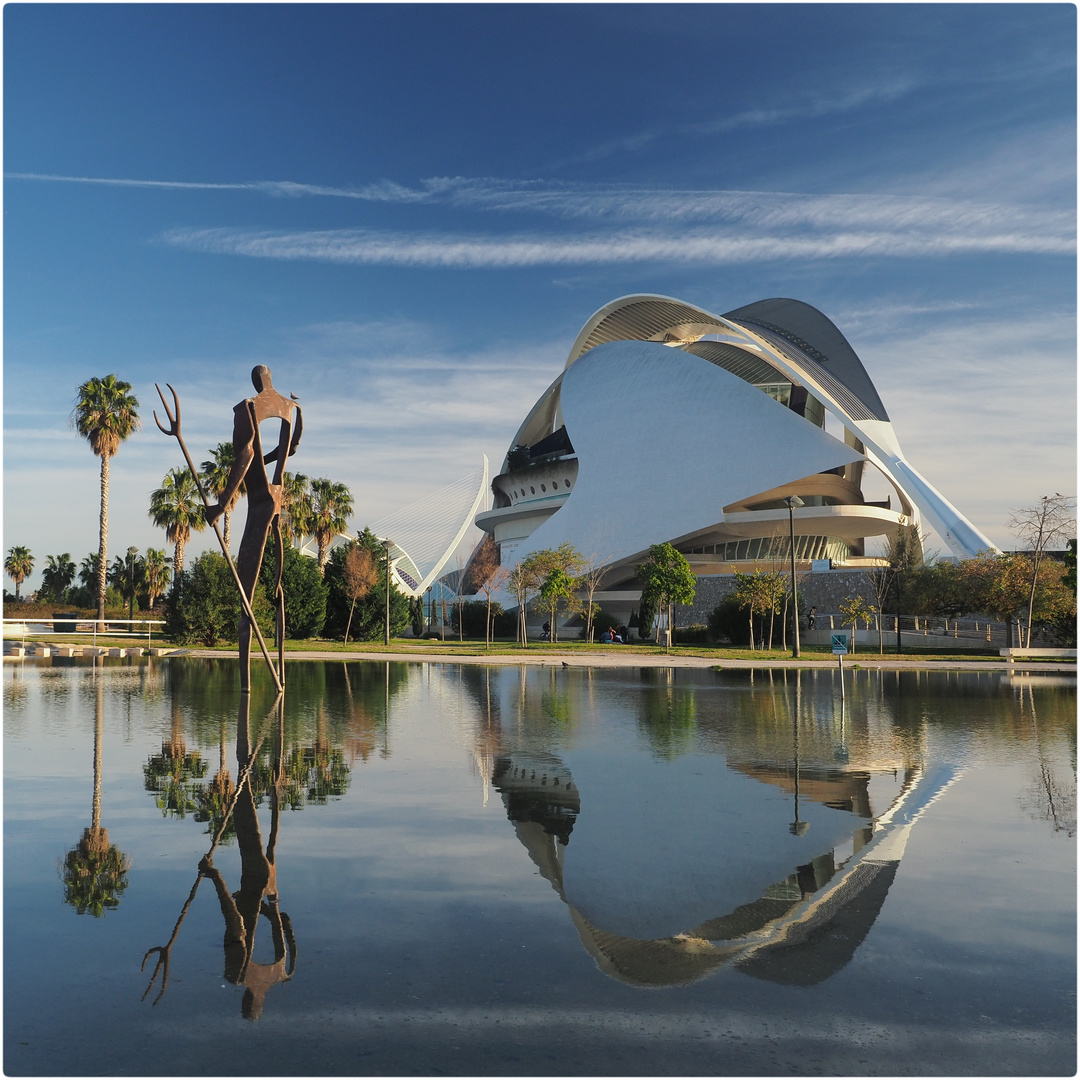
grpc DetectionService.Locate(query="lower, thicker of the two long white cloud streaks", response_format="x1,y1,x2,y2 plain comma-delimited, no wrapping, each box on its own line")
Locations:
160,221,1076,269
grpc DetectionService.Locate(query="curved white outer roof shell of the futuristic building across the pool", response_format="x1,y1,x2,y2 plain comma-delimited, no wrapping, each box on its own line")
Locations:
490,294,994,562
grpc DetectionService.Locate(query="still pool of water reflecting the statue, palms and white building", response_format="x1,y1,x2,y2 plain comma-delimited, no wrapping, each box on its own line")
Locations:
3,658,1077,1076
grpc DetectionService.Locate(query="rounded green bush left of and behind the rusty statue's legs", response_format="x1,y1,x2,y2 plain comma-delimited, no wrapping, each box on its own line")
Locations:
165,551,274,648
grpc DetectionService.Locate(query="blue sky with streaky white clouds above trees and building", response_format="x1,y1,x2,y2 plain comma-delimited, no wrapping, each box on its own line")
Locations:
3,4,1077,588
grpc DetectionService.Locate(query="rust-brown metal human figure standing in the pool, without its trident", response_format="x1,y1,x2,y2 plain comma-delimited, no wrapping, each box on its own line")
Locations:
206,364,303,692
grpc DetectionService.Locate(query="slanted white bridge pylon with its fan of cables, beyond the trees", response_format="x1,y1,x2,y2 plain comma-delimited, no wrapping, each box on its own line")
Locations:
302,454,490,597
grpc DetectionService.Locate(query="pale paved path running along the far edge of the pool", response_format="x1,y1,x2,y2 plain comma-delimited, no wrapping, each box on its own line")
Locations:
173,647,1077,675
